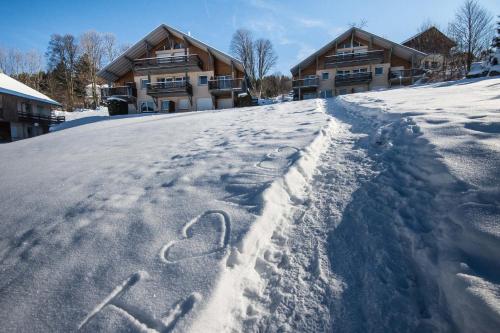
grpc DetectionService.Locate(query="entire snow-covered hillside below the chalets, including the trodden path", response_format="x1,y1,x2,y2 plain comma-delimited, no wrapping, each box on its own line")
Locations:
0,79,500,332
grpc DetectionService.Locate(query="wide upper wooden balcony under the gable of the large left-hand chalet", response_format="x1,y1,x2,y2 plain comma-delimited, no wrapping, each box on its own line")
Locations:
133,54,203,74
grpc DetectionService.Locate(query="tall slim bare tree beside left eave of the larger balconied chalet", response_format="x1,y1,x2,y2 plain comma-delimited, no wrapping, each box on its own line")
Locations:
80,31,104,108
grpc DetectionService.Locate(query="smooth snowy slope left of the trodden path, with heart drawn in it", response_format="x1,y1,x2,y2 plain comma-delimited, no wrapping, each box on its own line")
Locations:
0,101,327,332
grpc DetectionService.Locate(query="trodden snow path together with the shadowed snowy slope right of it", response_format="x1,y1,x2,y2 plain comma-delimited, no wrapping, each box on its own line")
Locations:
193,79,500,332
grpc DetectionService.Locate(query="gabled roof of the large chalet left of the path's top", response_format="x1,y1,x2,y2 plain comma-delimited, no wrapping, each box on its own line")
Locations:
97,24,244,82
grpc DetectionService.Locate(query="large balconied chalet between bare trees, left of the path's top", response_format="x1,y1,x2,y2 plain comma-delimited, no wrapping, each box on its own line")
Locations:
98,24,247,114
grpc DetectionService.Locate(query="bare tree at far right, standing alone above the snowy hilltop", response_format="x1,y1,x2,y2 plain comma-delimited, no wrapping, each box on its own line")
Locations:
449,0,493,70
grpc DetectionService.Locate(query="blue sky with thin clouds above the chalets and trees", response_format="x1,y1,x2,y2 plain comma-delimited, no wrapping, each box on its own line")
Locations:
0,0,500,74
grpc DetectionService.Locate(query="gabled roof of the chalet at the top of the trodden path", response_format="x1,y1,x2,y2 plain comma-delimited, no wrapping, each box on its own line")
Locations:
290,27,426,74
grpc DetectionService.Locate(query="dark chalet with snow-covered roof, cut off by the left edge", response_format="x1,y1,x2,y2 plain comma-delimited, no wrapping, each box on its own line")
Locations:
0,73,64,142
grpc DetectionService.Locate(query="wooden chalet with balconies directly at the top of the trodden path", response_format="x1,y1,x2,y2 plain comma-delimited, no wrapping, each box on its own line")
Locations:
291,28,426,100
